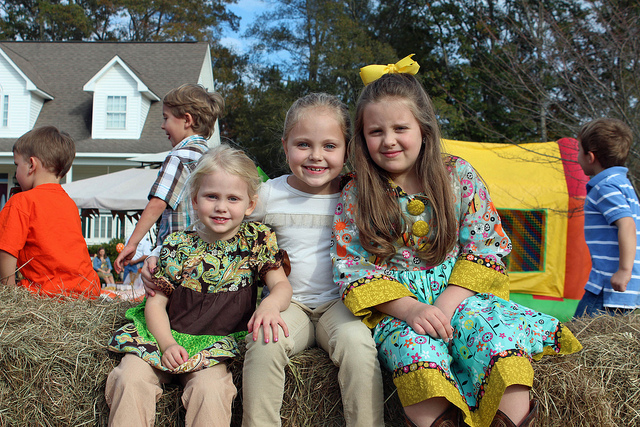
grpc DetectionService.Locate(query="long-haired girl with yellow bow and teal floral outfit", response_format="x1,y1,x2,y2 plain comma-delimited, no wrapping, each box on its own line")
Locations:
332,67,581,427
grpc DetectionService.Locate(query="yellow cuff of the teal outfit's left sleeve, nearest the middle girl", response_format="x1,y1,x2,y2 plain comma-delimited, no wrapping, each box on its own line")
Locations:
344,279,415,329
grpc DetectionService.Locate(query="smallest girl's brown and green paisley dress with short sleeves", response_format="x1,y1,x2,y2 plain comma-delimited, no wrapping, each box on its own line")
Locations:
108,222,287,374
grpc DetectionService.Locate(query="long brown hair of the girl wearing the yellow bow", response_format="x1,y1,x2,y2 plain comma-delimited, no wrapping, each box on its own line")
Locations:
349,74,457,265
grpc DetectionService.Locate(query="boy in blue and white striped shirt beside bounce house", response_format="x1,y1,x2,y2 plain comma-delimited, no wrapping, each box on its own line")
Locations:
575,118,640,316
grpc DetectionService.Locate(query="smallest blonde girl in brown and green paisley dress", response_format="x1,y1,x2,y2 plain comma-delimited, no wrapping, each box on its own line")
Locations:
105,145,292,426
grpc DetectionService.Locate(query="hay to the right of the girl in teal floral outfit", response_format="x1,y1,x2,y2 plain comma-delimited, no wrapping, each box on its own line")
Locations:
534,310,640,427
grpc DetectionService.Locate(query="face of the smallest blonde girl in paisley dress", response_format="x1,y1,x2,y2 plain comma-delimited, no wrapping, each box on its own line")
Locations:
193,170,256,243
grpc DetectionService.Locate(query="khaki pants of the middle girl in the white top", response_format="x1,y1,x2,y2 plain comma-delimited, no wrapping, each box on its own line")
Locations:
242,300,384,427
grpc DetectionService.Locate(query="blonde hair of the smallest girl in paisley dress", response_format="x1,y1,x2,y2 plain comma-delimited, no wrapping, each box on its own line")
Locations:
189,144,262,199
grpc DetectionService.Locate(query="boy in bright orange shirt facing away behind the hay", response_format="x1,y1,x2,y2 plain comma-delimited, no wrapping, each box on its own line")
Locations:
0,126,100,298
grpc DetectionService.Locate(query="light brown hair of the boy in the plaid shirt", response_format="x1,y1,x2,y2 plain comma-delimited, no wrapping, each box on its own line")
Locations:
162,83,224,139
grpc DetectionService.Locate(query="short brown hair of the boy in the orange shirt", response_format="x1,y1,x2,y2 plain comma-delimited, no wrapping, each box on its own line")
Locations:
13,126,76,178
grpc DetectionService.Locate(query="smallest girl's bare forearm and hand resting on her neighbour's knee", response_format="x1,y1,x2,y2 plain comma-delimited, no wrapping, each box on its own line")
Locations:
248,267,293,342
